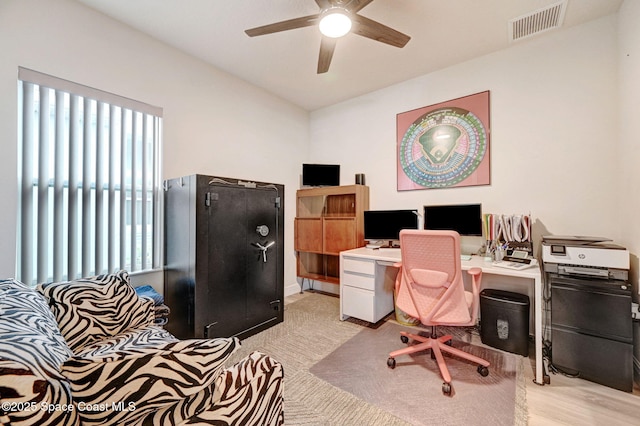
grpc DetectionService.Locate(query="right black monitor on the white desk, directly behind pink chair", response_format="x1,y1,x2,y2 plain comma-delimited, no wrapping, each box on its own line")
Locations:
424,204,482,236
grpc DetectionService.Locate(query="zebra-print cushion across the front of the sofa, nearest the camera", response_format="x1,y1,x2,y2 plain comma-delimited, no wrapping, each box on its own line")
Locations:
62,337,240,424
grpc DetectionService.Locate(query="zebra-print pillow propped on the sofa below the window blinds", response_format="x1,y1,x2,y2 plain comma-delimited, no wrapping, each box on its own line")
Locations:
37,271,154,353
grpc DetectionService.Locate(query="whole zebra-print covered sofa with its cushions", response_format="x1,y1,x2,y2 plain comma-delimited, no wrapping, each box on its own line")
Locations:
0,271,284,426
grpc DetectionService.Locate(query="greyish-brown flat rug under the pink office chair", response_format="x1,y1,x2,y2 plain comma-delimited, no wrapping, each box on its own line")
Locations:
310,321,521,425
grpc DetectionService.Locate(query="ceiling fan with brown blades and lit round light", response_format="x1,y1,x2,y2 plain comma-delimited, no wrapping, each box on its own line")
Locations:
245,0,411,74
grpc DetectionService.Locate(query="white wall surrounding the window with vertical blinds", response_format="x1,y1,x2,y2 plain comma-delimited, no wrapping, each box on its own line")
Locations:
0,0,309,289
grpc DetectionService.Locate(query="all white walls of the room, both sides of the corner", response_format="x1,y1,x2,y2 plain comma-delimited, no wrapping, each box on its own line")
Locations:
0,0,640,302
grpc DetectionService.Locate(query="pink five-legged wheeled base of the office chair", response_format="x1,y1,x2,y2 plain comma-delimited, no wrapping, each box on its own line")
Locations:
387,328,490,394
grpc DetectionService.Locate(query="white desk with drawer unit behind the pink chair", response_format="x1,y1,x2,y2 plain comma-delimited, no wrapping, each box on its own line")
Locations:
340,248,544,385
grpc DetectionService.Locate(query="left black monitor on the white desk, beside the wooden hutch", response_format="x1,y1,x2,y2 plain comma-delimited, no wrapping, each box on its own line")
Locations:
364,210,418,242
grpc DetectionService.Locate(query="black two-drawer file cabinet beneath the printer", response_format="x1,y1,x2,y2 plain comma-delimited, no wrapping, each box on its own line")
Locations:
549,274,633,392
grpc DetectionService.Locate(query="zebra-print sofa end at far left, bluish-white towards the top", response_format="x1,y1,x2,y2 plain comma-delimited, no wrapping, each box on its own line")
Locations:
0,280,78,425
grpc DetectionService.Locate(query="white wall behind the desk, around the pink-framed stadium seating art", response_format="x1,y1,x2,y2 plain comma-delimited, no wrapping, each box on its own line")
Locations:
310,16,621,258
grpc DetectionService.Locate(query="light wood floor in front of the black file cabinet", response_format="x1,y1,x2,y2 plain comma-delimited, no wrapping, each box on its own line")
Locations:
285,293,640,426
